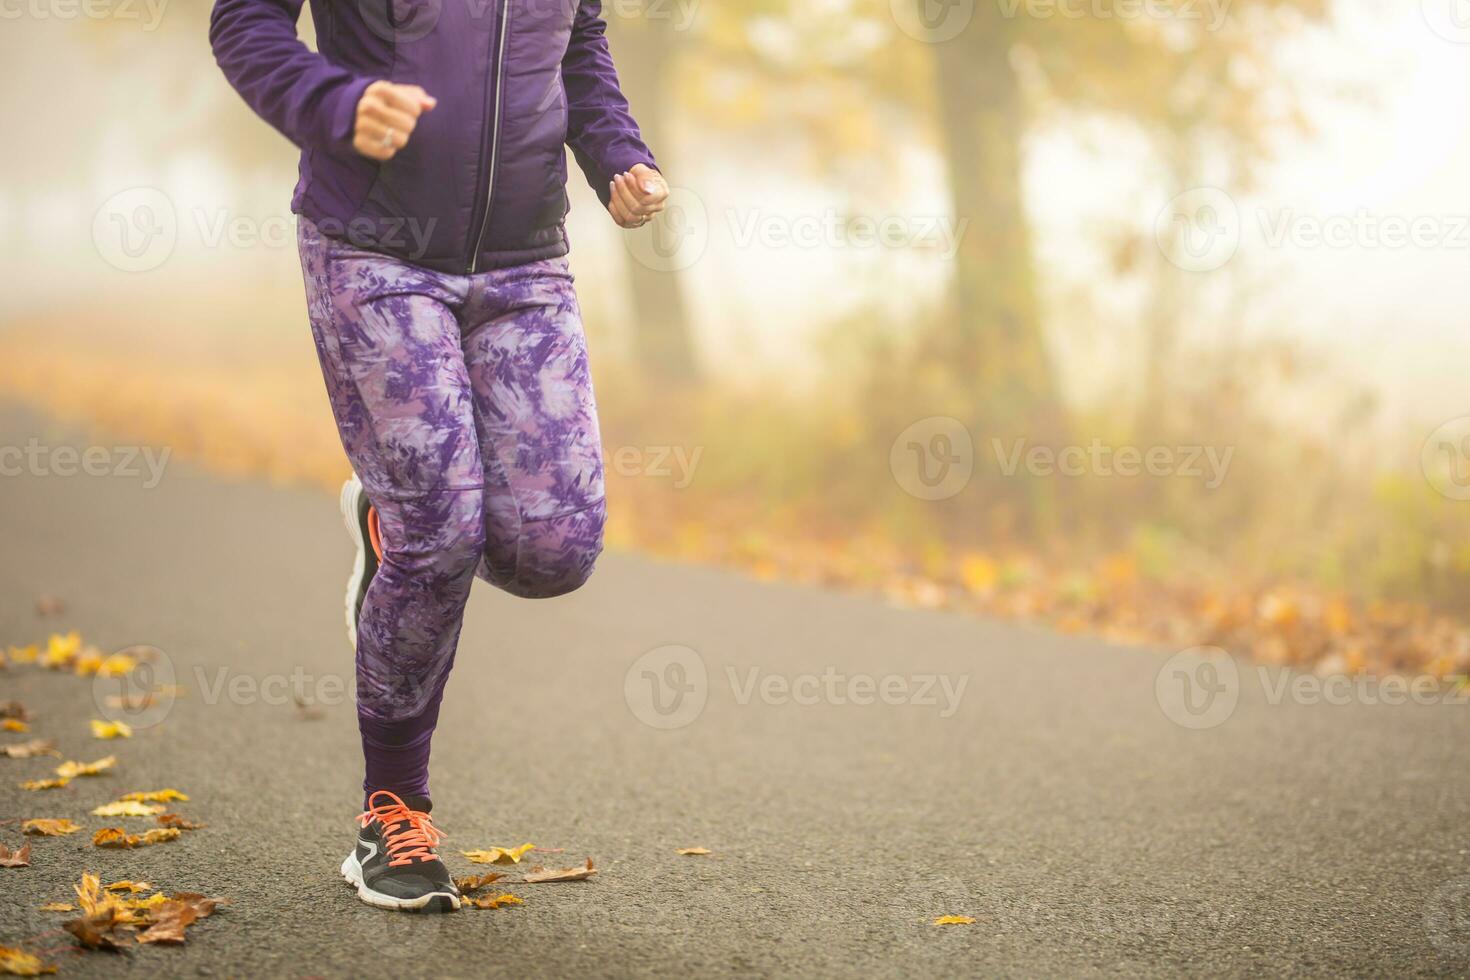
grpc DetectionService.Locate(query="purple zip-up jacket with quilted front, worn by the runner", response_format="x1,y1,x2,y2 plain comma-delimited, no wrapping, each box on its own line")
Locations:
209,0,654,273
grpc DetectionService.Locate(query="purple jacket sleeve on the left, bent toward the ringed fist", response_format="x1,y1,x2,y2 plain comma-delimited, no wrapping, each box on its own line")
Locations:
209,0,375,154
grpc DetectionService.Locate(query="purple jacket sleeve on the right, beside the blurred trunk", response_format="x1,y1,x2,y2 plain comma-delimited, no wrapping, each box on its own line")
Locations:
562,0,659,206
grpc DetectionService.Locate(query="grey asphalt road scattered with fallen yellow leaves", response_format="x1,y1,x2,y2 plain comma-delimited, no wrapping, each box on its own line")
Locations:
0,411,1470,977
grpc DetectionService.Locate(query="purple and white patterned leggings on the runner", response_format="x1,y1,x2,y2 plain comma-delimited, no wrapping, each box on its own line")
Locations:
298,219,606,796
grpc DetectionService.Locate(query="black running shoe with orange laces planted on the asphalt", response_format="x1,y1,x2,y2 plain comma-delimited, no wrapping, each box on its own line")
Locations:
343,790,460,912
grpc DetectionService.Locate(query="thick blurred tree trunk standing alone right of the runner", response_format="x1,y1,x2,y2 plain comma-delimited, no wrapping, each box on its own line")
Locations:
917,10,1058,423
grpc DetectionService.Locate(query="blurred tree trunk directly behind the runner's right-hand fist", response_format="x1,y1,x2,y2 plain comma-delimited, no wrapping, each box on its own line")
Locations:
609,16,698,382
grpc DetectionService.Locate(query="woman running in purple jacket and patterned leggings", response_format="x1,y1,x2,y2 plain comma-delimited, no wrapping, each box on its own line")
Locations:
210,0,669,912
